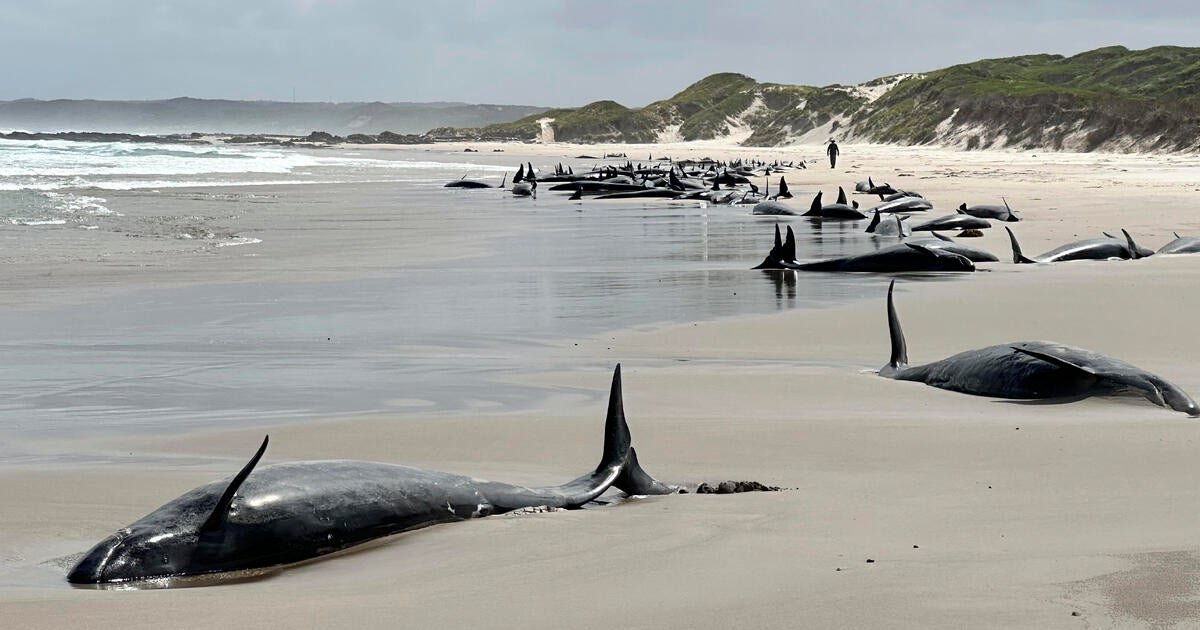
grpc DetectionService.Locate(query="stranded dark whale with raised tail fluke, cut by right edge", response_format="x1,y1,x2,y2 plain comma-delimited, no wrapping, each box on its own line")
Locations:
880,281,1200,418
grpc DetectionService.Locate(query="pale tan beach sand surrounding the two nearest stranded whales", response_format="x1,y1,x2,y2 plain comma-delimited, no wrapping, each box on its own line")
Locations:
0,139,1200,629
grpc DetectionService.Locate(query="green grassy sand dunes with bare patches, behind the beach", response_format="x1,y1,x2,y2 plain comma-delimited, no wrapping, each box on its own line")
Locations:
430,47,1200,151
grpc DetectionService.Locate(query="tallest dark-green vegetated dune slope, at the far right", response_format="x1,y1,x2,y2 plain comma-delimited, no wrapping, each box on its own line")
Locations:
852,47,1200,150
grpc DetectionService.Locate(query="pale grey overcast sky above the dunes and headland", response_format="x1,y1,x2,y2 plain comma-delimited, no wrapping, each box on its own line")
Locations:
0,0,1200,106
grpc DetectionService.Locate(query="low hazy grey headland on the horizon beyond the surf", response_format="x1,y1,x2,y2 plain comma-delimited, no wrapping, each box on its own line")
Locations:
0,97,546,136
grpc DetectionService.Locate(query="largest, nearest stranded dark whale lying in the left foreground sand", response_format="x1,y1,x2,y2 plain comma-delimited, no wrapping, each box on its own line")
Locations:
67,365,677,586
